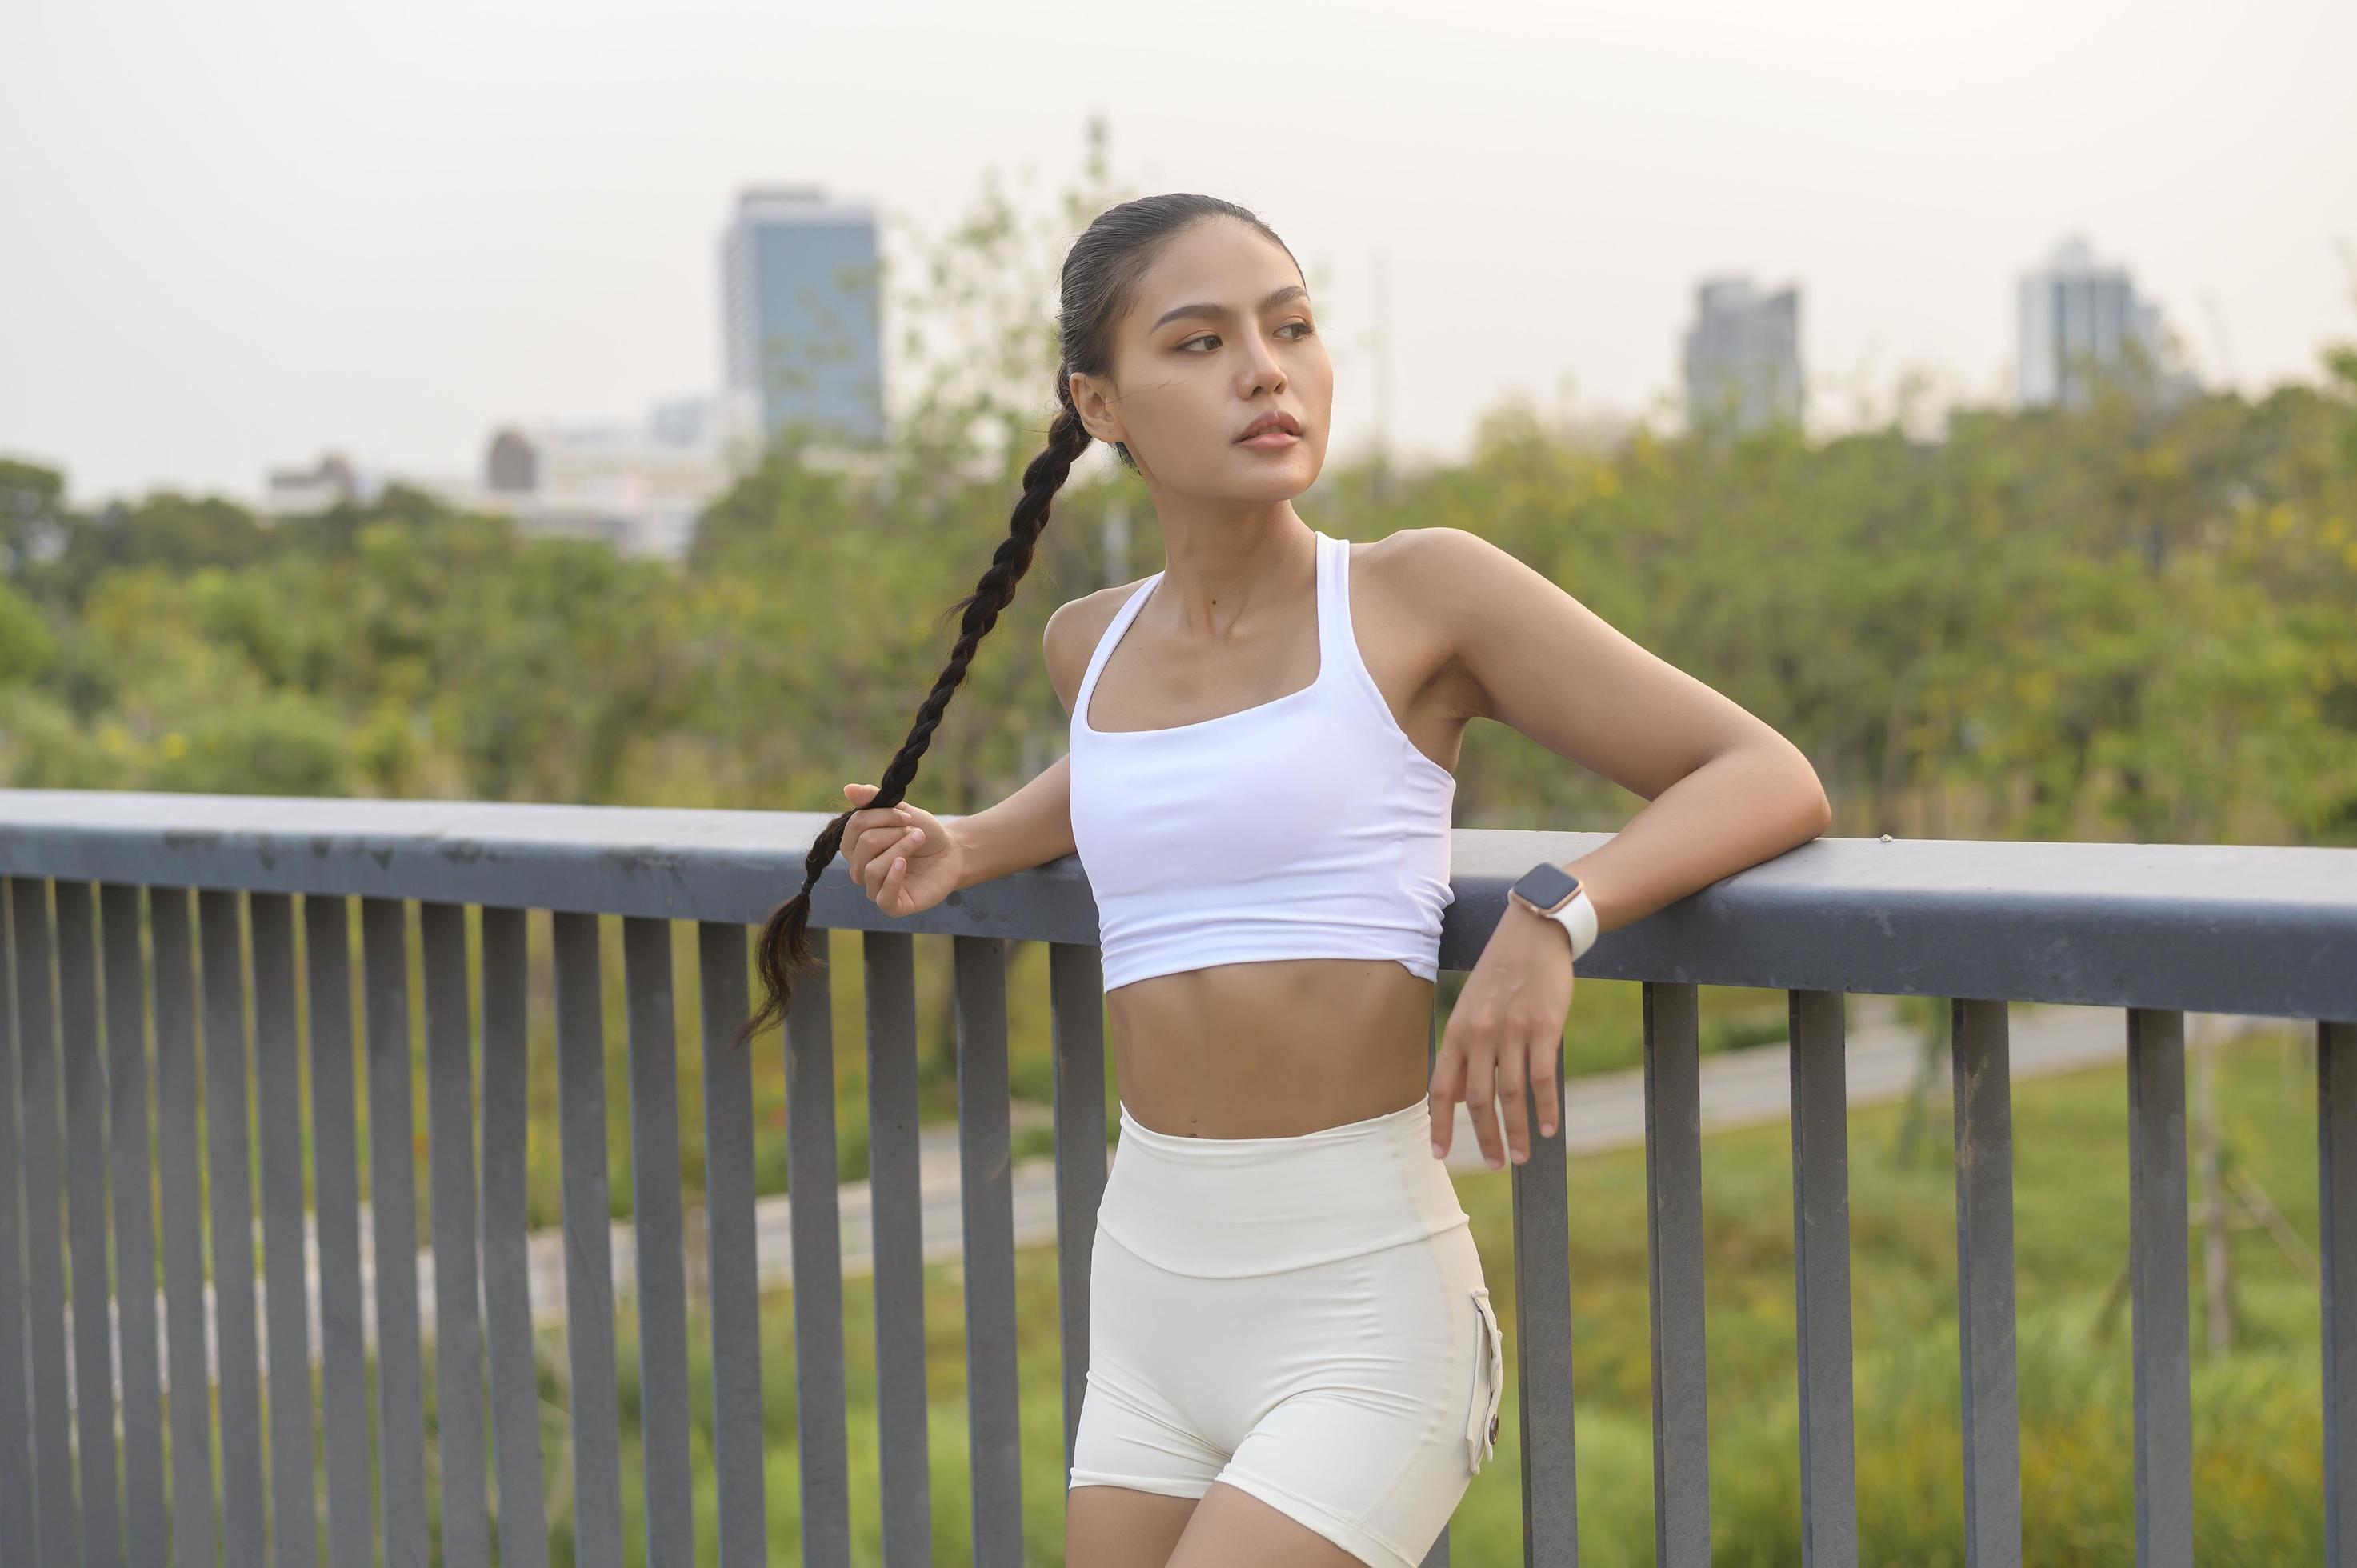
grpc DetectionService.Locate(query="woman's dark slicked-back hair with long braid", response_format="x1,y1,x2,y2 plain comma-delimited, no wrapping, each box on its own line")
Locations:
735,194,1299,1045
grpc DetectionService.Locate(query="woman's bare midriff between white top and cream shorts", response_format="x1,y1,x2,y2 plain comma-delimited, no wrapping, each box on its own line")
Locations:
1106,958,1433,1139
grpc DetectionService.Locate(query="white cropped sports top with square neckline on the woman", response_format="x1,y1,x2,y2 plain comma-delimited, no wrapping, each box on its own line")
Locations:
1070,528,1457,990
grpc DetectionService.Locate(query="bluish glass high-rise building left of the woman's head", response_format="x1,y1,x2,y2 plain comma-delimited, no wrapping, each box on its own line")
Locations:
721,186,884,446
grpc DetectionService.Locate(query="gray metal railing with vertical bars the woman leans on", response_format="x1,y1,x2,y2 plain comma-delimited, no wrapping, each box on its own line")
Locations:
0,790,2357,1568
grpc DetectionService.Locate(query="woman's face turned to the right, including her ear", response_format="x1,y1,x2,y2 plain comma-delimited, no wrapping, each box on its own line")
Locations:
1072,217,1334,500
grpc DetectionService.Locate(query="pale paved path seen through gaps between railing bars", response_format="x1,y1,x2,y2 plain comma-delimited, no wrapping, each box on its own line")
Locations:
96,998,2295,1386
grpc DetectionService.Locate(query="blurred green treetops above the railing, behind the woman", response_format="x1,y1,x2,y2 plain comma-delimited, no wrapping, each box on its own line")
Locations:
0,125,2357,844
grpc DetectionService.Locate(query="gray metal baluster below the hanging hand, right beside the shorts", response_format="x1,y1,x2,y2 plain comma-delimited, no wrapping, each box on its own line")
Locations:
1499,1032,1579,1568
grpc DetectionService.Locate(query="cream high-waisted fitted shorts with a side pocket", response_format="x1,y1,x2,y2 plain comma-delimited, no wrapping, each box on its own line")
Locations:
1070,1098,1504,1568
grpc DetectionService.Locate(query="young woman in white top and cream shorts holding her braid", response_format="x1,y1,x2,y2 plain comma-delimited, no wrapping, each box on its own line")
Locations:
747,196,1831,1568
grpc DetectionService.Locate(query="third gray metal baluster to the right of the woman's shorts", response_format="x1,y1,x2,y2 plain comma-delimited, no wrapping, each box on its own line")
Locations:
1789,990,1857,1568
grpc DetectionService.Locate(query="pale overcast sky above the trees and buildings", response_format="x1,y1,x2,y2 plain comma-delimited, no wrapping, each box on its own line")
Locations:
0,0,2357,502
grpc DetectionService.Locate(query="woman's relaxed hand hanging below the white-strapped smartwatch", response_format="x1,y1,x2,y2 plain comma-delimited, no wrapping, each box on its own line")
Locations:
1431,898,1572,1170
